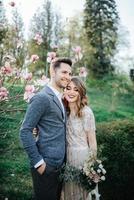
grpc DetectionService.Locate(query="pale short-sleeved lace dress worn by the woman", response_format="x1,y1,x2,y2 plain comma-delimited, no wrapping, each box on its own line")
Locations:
62,106,95,200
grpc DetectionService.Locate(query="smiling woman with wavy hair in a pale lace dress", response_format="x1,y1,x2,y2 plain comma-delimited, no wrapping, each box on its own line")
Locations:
62,77,97,200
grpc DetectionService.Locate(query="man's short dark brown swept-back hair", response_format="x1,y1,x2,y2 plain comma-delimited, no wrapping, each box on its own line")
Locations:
51,58,72,70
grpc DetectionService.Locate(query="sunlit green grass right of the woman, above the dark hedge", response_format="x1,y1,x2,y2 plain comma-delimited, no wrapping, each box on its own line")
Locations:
87,77,134,123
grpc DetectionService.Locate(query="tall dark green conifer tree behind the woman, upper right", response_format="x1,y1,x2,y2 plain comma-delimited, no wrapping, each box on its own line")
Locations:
84,0,119,78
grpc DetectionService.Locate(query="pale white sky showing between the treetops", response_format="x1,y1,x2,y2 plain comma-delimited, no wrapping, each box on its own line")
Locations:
4,0,134,73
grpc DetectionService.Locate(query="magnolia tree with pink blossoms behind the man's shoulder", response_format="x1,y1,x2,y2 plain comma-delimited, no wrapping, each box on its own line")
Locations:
0,1,87,113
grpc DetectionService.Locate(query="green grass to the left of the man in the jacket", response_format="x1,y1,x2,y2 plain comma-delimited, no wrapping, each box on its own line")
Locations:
0,86,32,200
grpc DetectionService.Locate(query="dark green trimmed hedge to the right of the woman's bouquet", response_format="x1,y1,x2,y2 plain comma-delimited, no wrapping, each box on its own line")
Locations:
97,120,134,200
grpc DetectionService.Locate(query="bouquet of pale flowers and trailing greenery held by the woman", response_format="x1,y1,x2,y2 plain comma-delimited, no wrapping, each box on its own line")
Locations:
60,154,106,192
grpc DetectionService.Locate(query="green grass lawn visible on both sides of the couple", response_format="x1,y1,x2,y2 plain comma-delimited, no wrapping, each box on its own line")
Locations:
0,76,134,200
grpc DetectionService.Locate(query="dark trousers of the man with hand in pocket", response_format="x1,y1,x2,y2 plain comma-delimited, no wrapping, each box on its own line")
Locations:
31,164,62,200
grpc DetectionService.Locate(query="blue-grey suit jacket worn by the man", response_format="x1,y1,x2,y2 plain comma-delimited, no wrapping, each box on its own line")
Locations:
20,86,66,167
